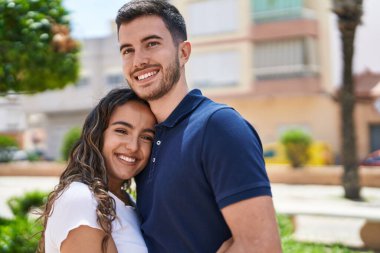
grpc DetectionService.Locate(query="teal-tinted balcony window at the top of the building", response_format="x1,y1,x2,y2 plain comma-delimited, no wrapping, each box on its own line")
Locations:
251,0,314,23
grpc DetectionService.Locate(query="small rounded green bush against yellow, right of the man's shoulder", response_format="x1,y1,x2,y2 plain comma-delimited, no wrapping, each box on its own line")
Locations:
281,129,311,168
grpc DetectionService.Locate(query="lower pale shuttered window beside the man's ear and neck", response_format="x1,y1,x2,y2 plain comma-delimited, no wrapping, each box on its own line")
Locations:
188,51,241,88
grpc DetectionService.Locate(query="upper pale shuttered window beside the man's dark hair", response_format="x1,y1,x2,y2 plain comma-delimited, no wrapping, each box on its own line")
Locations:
188,0,239,36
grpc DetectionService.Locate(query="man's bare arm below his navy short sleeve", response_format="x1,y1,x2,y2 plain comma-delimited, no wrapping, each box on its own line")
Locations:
222,196,282,253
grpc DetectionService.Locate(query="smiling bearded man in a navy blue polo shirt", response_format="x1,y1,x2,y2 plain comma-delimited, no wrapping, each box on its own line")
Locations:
116,0,281,253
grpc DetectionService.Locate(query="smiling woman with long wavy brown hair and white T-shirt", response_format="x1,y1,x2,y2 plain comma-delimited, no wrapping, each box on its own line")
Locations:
39,89,156,253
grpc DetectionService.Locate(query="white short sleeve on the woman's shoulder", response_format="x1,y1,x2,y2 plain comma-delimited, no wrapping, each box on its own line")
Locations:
45,182,101,250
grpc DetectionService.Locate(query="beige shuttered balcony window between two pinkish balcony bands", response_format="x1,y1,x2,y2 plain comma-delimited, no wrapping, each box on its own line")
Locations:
254,38,319,80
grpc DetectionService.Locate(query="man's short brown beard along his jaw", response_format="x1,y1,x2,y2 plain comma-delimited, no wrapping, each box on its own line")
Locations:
131,53,181,101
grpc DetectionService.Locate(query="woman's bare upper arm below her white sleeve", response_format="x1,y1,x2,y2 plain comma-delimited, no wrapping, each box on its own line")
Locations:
61,226,117,253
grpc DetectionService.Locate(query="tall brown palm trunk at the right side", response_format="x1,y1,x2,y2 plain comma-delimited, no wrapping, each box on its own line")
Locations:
333,0,363,199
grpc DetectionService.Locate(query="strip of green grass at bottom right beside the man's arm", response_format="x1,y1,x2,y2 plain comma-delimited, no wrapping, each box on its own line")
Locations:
277,215,373,253
